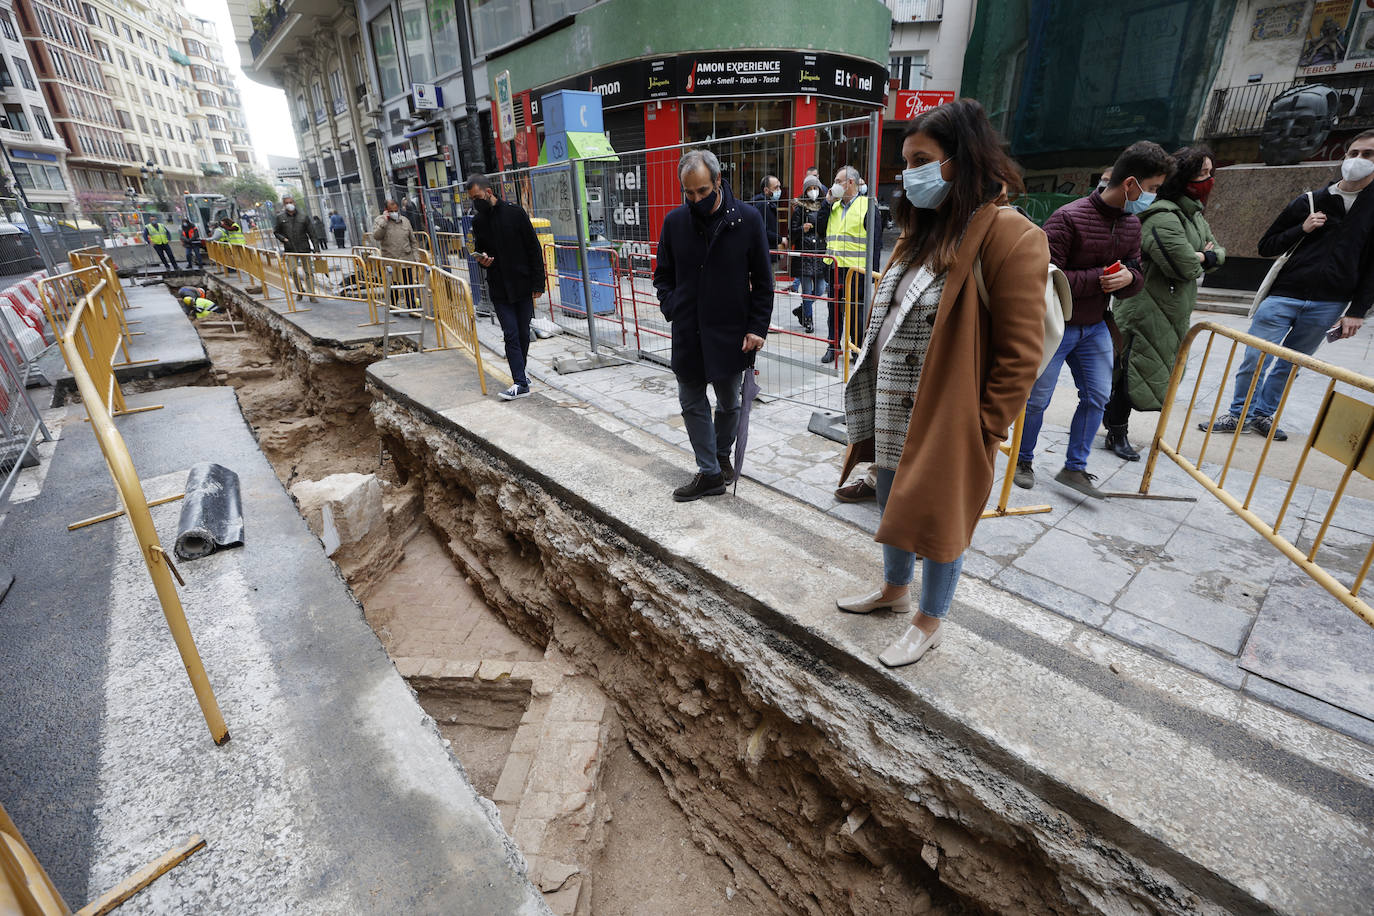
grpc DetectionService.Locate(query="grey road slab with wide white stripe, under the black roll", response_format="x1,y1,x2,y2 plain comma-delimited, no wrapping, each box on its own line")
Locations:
0,387,548,915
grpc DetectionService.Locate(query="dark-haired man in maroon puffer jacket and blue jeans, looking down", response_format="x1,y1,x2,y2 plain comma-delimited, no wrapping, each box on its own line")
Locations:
1014,140,1173,499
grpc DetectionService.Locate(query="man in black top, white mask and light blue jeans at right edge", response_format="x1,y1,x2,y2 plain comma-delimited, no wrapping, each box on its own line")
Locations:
1198,130,1374,442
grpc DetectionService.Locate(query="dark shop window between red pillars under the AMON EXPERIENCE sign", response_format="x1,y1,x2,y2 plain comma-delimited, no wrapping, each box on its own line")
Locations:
683,99,791,201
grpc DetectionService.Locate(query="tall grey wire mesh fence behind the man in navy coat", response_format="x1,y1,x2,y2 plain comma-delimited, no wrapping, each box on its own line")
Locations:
365,117,881,411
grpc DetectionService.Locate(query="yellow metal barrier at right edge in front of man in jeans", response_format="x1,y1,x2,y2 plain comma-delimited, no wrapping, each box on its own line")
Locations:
1140,321,1374,626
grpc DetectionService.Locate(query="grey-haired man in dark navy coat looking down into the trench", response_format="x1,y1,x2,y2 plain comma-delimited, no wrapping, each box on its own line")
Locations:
654,150,774,503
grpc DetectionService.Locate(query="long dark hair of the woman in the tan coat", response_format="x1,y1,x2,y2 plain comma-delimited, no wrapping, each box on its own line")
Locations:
889,99,1025,273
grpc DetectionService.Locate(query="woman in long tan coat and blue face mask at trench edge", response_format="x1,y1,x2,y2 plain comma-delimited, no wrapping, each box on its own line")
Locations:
837,99,1050,667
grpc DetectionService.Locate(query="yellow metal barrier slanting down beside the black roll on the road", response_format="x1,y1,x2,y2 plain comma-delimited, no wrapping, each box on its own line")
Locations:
59,279,229,744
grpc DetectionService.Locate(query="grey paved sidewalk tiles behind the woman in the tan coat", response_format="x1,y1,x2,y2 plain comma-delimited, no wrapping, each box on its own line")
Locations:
478,314,1374,743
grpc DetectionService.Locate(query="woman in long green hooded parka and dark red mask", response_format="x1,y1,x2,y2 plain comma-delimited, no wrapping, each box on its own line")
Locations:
1102,147,1226,461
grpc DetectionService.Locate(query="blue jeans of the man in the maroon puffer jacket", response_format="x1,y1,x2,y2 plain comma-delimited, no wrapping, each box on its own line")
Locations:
1017,321,1112,471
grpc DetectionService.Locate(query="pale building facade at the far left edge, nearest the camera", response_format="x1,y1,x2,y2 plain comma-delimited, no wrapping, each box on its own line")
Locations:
0,0,71,213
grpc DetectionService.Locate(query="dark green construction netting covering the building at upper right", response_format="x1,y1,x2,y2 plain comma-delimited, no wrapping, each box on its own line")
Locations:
960,0,1235,157
